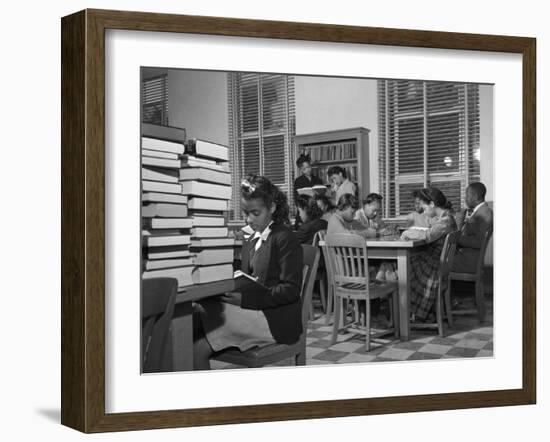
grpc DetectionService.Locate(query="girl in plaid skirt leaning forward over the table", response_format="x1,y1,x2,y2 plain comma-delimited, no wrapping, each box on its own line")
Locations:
402,187,457,322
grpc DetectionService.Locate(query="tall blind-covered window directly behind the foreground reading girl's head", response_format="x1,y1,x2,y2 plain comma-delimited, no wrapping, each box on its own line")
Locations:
228,72,295,221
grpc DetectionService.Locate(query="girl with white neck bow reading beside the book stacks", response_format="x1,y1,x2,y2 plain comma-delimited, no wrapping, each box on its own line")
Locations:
193,175,303,370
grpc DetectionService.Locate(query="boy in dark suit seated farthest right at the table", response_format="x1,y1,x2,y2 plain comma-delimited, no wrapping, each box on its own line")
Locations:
452,182,493,273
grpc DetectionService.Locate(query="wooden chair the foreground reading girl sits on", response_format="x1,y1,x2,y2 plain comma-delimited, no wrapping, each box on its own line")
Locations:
212,244,320,368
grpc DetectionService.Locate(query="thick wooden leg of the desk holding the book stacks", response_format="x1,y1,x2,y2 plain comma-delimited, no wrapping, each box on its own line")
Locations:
172,301,193,371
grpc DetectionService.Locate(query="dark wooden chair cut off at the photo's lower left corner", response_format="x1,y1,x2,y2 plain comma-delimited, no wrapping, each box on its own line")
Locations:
141,278,178,373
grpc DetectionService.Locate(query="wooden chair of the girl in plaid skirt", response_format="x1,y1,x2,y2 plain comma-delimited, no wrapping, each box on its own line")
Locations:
411,231,460,337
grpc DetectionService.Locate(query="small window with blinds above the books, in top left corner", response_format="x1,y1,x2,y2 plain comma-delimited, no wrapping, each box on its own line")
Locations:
141,74,168,126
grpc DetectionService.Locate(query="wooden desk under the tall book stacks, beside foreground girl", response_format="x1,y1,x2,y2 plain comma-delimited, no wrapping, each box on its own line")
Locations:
172,279,235,371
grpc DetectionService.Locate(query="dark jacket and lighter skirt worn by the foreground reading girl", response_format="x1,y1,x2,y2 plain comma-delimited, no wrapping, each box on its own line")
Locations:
201,224,303,351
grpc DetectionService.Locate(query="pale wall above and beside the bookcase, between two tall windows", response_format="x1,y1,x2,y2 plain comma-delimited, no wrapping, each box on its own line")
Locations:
295,76,378,192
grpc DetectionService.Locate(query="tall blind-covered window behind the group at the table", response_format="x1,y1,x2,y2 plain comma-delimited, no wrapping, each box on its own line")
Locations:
378,80,480,218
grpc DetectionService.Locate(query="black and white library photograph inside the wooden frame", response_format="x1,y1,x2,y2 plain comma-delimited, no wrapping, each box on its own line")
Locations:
140,67,495,373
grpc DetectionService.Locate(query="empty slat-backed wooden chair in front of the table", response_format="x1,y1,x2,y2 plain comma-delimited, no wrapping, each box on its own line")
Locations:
325,233,399,351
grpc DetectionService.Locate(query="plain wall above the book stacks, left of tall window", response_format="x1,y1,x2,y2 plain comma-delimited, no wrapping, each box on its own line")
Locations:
168,69,229,146
